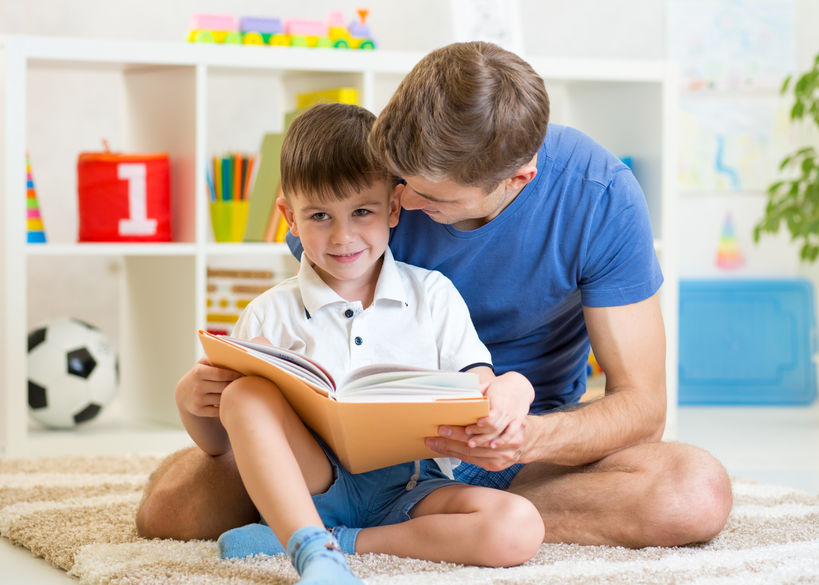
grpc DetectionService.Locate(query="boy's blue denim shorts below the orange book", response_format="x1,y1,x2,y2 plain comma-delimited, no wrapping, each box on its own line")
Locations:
313,439,464,528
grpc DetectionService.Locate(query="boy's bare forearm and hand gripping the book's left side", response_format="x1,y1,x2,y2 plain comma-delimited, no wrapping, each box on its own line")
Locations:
175,358,241,456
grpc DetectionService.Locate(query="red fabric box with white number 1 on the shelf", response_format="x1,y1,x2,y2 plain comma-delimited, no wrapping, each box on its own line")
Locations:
77,152,171,242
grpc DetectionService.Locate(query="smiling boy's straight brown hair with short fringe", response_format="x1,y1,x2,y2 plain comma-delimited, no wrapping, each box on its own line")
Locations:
281,103,394,201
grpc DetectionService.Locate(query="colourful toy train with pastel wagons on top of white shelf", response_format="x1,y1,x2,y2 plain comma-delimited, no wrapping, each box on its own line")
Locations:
188,9,375,49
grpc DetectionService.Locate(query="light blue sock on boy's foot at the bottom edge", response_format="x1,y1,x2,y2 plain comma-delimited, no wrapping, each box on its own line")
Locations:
287,526,363,585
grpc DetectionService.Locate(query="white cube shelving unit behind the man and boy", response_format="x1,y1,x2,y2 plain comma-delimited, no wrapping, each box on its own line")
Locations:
0,36,677,456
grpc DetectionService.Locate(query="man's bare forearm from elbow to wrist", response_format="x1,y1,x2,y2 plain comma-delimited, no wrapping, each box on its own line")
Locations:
520,390,665,466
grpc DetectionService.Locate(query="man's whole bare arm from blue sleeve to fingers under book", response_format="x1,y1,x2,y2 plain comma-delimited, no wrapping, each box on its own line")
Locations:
427,294,666,470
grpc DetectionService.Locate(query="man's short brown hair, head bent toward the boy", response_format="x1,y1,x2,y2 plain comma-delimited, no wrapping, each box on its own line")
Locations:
370,41,549,192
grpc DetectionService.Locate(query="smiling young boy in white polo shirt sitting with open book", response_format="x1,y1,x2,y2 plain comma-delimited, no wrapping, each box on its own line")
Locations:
177,104,544,583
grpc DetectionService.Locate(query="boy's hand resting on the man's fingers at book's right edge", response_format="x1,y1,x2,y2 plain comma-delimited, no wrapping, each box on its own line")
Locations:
464,372,535,449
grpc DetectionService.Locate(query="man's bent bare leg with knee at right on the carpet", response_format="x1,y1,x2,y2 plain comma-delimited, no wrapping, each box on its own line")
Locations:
509,443,733,548
